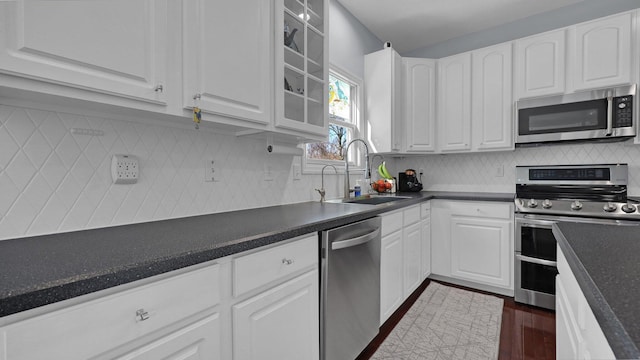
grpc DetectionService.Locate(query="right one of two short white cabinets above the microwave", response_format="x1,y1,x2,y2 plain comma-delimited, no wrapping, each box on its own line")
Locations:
570,13,633,90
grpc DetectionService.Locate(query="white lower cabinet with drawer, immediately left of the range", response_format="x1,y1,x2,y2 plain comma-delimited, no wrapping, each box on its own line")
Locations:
431,200,513,295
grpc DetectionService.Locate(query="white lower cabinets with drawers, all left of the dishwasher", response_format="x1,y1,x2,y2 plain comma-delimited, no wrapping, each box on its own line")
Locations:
0,233,320,360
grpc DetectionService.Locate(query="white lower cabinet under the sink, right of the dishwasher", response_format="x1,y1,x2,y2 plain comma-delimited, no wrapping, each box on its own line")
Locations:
380,205,423,325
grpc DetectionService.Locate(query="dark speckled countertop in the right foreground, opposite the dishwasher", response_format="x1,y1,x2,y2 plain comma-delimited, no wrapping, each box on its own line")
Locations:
553,222,640,359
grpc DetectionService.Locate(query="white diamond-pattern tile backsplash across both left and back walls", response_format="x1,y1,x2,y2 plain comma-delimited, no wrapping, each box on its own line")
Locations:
0,105,640,240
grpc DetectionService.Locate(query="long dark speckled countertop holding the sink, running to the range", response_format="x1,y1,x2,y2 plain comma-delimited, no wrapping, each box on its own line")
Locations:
0,192,514,317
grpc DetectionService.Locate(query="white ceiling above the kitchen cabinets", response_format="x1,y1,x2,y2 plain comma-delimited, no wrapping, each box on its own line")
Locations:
338,0,583,53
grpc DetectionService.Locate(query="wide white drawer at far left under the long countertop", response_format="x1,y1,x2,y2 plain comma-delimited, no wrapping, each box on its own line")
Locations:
6,265,221,360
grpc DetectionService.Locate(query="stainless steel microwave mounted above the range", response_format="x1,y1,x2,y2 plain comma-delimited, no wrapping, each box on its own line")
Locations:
516,84,637,146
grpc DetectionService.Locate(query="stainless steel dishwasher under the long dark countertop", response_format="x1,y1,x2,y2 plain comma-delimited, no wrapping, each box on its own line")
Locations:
320,217,381,360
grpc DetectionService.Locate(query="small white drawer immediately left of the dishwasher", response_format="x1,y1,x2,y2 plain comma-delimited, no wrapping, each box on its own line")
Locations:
233,234,318,296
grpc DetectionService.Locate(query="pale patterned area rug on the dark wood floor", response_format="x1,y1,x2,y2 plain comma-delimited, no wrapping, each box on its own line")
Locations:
371,282,503,360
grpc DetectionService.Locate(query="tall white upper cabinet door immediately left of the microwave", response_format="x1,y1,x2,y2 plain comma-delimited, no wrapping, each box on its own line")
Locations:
471,42,514,151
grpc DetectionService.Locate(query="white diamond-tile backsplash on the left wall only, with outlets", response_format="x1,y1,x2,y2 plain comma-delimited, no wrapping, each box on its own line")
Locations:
0,105,330,239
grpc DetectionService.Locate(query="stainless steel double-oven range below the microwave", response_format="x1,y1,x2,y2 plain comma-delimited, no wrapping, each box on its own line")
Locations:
514,164,640,309
